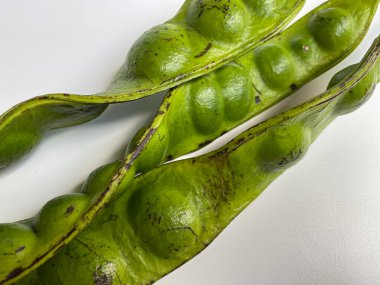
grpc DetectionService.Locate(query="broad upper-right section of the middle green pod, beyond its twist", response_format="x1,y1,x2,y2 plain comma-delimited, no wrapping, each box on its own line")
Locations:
130,0,378,161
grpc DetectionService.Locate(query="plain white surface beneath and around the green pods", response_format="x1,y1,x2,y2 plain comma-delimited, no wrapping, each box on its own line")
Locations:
0,0,380,285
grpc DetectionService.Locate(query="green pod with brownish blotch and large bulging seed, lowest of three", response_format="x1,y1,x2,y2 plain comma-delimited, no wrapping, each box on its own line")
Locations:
16,37,380,284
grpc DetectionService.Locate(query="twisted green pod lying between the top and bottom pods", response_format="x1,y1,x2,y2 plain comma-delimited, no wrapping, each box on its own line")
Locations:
0,1,378,280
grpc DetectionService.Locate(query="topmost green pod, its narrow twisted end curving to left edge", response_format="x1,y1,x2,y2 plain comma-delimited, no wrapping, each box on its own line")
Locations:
0,0,305,168
